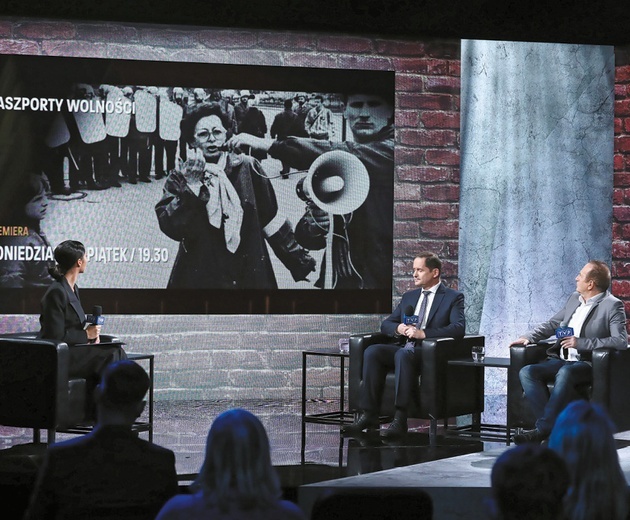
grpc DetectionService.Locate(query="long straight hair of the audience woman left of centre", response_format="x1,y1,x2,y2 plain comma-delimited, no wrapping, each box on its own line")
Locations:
193,408,282,511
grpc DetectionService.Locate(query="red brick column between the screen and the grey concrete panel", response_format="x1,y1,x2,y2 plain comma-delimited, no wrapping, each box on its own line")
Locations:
389,42,460,294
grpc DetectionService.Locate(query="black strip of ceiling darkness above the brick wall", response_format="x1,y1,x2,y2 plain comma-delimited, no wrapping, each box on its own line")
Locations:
0,0,630,44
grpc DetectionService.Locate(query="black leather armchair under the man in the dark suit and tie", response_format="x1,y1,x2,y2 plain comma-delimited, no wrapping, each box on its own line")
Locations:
348,332,485,445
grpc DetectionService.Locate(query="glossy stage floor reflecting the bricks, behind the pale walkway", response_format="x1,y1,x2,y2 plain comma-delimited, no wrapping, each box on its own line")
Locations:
0,399,504,487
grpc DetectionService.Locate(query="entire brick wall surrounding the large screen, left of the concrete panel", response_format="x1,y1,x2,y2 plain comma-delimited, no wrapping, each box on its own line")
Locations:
0,19,460,399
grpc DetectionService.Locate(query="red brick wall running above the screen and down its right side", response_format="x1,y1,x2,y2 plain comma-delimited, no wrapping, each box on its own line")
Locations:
0,19,460,295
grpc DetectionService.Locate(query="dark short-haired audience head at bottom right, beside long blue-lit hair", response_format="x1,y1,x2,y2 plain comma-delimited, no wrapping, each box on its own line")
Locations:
489,444,570,520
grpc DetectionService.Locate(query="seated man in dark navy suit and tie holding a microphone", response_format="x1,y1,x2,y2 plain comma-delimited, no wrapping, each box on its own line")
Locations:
344,252,466,437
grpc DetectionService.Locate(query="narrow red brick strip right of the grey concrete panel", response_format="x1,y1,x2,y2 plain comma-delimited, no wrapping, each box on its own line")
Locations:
612,49,630,315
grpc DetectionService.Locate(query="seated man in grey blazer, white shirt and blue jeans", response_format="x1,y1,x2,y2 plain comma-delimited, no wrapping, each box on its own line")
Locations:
510,260,628,444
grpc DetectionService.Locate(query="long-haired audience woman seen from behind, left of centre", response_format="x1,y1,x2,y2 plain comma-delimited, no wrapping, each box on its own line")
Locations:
156,409,305,520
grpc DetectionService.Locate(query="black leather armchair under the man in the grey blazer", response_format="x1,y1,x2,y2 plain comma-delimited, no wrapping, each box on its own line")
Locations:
507,343,630,431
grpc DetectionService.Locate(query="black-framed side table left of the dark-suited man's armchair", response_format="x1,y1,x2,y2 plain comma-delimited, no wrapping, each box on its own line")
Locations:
301,348,354,464
